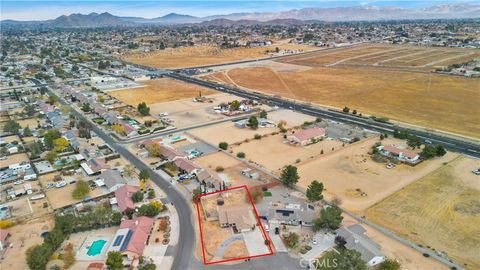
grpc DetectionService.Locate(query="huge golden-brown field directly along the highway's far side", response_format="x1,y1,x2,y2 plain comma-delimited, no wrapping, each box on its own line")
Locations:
207,67,480,138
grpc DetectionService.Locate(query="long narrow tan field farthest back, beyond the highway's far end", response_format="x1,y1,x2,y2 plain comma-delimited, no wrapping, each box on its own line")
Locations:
122,43,318,68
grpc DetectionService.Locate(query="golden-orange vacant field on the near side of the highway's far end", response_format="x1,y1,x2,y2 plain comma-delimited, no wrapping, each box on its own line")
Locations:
108,78,217,107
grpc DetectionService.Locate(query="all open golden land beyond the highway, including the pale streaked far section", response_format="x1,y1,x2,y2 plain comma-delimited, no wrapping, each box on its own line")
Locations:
204,45,480,138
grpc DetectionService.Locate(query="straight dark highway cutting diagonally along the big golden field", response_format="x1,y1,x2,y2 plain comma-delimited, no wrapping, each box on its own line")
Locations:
165,72,480,158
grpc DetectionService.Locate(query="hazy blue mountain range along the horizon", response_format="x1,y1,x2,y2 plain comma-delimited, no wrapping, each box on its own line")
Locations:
1,3,480,28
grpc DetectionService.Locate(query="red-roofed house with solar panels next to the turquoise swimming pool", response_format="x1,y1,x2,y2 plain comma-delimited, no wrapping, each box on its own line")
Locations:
108,216,154,261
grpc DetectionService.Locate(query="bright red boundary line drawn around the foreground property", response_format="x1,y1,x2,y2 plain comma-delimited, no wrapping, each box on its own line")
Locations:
195,185,273,265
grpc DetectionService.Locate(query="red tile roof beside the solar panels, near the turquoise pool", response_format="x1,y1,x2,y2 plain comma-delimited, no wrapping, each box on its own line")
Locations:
120,216,154,255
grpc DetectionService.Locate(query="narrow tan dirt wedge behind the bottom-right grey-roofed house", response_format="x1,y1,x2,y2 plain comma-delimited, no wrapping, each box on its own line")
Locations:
343,214,449,270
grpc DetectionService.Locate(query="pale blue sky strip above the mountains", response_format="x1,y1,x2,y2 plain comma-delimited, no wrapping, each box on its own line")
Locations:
0,0,479,20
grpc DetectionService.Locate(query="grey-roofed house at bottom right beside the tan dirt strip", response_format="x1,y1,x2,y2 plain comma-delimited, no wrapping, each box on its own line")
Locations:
336,224,385,266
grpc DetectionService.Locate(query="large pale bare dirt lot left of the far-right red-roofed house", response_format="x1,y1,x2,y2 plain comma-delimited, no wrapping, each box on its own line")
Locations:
298,137,458,214
